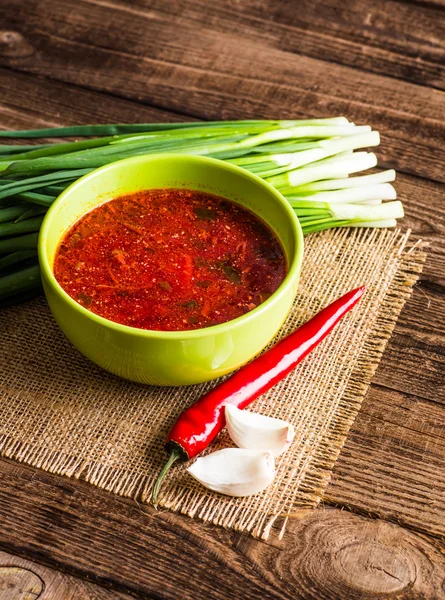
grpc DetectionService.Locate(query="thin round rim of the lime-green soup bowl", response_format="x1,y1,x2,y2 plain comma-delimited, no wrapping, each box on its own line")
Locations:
38,153,304,341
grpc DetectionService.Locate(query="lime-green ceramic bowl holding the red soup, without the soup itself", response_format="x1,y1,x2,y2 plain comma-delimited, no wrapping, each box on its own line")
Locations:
39,154,303,385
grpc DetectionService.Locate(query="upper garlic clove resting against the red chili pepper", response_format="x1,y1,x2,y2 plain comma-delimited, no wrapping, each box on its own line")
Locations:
225,404,295,458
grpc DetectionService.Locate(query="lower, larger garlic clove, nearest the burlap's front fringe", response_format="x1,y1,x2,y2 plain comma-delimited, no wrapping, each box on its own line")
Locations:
187,448,275,496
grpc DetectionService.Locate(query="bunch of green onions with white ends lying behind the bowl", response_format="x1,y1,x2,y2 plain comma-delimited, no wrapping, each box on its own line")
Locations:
0,117,403,304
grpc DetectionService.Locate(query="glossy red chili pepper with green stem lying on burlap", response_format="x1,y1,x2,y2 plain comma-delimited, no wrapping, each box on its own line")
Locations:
152,287,365,506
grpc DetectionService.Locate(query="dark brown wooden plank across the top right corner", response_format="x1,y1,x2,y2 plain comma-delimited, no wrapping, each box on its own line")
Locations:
89,0,445,89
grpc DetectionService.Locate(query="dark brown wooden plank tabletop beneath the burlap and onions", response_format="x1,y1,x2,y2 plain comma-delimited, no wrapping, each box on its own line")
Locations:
0,0,445,600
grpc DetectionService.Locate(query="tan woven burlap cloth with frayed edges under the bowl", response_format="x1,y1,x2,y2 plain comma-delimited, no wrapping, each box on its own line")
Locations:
0,229,425,538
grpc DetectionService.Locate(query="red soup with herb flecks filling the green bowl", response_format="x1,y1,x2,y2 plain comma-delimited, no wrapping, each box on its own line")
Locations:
54,189,287,331
